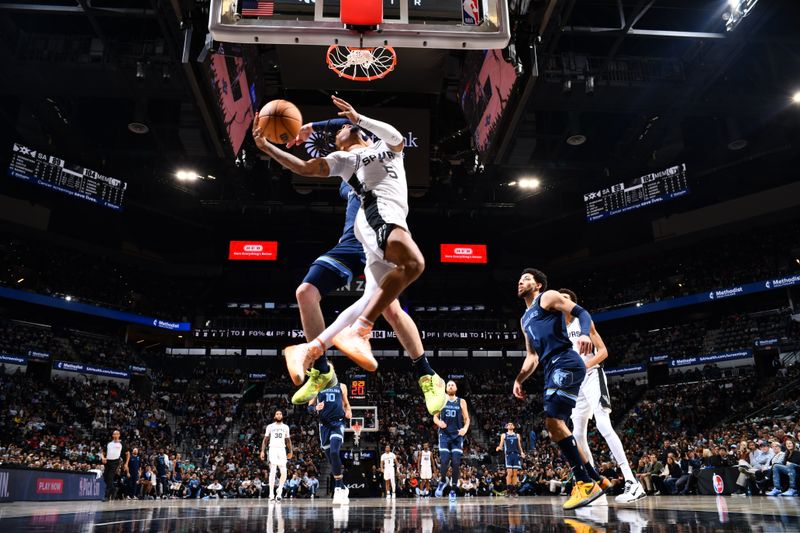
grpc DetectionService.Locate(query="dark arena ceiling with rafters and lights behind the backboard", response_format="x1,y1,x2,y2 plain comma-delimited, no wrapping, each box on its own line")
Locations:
0,0,800,227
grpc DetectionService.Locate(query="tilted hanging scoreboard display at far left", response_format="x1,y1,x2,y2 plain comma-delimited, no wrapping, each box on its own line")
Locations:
8,143,128,210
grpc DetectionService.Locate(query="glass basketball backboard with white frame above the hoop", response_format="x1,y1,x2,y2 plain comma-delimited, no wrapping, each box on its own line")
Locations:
209,0,511,50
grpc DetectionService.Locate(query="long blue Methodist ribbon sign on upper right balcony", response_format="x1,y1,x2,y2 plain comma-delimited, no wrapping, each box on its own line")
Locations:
592,274,800,322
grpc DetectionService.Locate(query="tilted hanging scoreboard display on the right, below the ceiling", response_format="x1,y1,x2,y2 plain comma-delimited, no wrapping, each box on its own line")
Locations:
583,164,689,222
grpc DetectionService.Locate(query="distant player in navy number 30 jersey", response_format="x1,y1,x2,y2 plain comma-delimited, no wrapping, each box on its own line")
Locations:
433,381,469,498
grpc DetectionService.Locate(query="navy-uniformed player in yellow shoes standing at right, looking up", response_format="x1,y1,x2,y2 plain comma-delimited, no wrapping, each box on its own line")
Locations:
513,268,604,509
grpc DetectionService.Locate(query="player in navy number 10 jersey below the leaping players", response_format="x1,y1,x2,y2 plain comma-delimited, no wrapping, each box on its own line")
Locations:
308,375,353,504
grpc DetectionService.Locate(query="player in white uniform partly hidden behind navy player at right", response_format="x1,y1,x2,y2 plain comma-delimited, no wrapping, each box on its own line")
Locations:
559,289,647,503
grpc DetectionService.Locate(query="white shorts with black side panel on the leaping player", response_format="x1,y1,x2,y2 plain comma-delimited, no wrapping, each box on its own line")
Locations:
355,198,410,284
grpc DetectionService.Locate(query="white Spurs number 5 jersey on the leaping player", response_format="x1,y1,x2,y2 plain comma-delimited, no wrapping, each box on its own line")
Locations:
325,140,408,230
